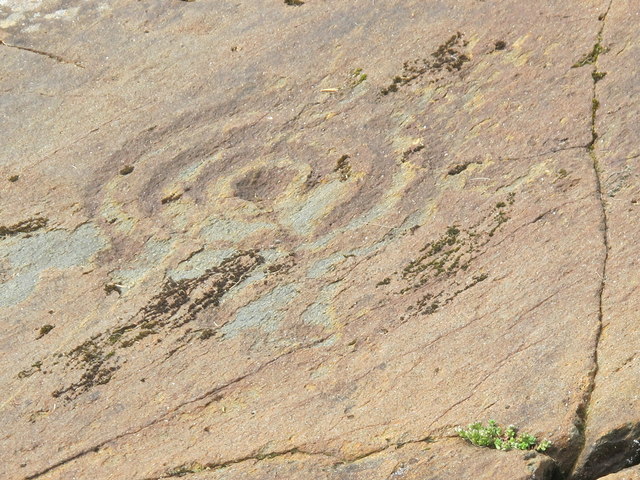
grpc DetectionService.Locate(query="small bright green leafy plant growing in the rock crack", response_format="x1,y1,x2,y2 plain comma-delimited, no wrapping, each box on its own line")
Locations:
456,420,551,452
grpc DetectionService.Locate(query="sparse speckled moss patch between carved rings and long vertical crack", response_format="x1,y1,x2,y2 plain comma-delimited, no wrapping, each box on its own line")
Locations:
398,194,515,315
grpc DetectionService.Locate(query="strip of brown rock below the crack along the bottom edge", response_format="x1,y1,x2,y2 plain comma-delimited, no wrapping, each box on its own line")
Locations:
43,440,555,480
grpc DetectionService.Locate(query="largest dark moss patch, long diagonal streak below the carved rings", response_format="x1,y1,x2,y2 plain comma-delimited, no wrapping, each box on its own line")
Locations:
18,250,264,401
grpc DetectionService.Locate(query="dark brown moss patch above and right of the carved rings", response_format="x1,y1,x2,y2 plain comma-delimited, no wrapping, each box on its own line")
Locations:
380,32,471,95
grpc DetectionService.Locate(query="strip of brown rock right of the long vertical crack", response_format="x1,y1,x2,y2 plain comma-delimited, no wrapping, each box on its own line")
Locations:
577,2,640,478
